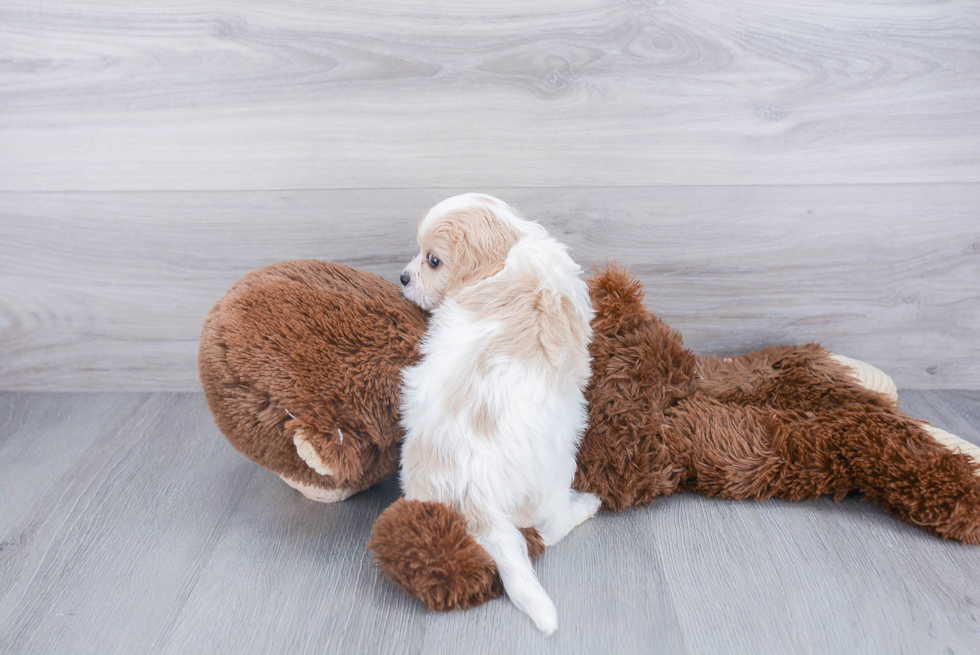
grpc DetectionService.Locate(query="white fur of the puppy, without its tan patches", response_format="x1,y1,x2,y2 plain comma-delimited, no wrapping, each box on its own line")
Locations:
401,194,600,634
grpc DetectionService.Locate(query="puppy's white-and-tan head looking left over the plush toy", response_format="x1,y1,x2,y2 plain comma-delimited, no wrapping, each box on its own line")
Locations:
401,193,525,309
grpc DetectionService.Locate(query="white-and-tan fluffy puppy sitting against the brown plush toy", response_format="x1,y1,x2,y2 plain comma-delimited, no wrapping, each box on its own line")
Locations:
401,194,600,634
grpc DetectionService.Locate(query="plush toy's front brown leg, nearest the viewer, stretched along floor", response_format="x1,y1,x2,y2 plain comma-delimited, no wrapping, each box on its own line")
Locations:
664,399,980,544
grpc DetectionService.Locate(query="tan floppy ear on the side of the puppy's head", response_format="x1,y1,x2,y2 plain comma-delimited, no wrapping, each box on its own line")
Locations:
433,207,520,294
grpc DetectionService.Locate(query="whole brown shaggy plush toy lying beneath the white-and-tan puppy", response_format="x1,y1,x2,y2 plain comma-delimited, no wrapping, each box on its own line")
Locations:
199,260,980,610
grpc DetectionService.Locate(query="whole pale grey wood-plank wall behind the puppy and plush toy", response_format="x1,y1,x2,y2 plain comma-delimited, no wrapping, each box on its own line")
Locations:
0,0,980,390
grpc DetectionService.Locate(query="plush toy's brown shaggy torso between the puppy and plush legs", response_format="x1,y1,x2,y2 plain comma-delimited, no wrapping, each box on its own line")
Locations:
575,266,697,511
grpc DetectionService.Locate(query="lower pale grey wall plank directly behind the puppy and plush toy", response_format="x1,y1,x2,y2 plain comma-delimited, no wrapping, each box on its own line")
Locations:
0,185,980,391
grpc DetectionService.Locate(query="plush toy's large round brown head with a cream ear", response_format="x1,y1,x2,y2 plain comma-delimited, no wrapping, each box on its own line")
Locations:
198,260,425,500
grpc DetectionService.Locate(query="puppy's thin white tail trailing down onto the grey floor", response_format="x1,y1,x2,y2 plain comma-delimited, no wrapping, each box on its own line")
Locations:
477,516,558,635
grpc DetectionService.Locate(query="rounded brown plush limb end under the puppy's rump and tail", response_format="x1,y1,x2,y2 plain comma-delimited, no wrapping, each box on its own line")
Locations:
368,498,544,611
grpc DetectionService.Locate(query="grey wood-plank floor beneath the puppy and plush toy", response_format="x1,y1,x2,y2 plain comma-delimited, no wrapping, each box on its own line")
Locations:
0,391,980,655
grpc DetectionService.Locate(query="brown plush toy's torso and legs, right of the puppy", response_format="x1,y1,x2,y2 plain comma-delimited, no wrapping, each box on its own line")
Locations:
576,267,980,543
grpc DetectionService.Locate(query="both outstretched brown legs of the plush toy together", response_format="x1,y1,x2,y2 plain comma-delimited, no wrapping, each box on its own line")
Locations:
688,345,980,544
